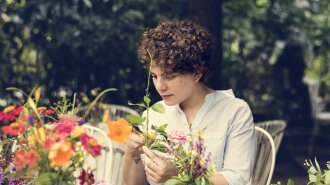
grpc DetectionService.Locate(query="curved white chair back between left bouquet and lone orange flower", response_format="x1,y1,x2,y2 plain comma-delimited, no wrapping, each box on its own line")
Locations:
83,125,116,183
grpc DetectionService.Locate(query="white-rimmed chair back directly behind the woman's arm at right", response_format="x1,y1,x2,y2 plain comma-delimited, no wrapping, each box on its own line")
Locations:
251,126,276,185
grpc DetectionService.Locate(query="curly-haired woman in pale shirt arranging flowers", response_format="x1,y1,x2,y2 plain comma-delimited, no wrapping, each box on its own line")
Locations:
123,21,256,185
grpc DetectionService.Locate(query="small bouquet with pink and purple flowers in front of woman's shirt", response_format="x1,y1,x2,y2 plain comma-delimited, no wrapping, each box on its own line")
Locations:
165,131,216,185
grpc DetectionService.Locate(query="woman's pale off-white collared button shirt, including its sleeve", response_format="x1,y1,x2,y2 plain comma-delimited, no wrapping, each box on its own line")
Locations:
142,90,257,185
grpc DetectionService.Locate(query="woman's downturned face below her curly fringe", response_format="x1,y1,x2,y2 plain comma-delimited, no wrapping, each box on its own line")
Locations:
151,66,199,106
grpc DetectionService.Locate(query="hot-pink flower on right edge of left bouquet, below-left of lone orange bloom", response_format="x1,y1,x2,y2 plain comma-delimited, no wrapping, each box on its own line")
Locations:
80,133,102,157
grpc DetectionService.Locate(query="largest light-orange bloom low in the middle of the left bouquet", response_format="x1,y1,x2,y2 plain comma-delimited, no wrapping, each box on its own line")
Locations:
48,142,72,167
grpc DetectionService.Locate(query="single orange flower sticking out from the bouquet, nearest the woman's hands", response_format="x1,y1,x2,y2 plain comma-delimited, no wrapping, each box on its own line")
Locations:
106,118,132,143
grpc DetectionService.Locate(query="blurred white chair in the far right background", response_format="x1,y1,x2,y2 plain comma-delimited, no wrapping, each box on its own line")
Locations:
303,77,330,155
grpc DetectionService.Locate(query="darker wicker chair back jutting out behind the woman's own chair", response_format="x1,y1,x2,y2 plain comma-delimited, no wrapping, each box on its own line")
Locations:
256,120,286,153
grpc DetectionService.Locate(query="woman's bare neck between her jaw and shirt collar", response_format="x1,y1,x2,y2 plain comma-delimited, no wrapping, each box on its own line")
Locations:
179,83,215,112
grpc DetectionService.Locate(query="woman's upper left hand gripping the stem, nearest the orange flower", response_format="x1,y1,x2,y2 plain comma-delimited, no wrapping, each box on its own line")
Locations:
126,131,144,159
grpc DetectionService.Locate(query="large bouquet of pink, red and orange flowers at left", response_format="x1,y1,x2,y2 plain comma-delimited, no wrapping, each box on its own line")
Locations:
0,87,115,185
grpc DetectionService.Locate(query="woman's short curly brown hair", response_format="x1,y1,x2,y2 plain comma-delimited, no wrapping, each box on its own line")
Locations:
138,20,213,81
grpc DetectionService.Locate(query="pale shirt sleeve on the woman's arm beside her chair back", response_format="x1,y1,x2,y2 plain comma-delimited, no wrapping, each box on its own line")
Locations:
218,101,257,185
